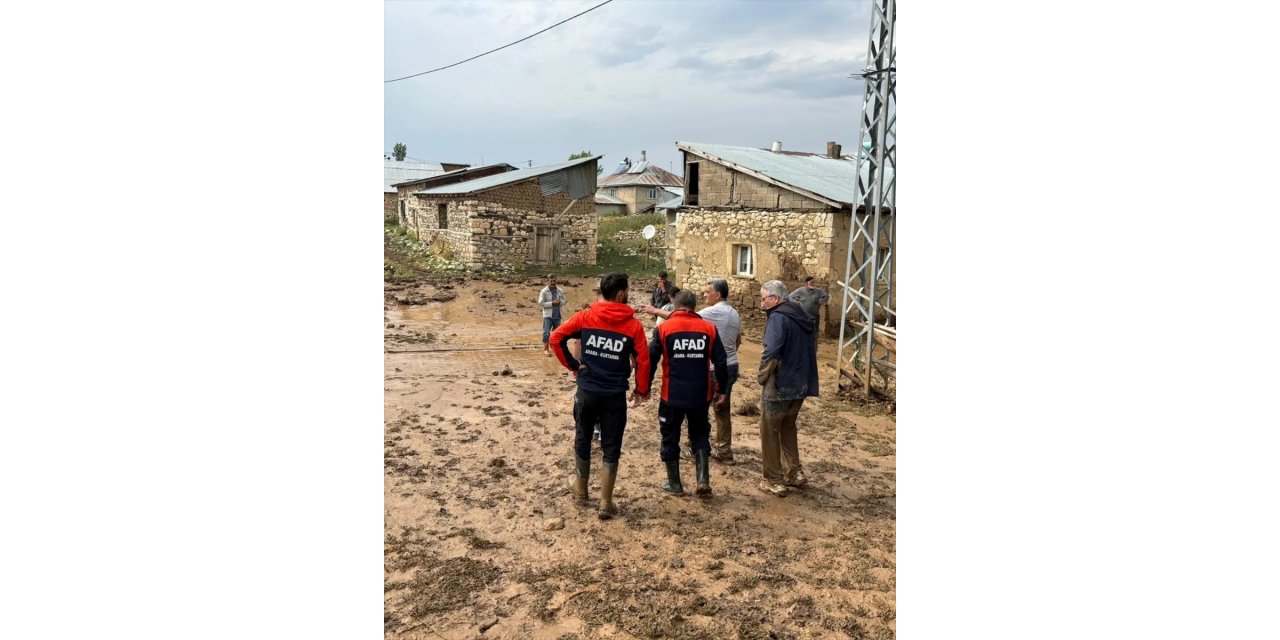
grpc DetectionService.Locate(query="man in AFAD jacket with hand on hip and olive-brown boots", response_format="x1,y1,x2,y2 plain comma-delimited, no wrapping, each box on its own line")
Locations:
550,273,650,520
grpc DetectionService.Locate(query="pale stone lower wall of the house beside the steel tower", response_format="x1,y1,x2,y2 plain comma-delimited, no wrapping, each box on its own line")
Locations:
669,207,847,324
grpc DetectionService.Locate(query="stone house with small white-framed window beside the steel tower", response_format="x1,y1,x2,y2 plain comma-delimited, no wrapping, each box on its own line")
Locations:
667,142,896,335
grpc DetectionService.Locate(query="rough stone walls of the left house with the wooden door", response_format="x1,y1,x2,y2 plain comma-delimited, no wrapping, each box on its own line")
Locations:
407,179,596,266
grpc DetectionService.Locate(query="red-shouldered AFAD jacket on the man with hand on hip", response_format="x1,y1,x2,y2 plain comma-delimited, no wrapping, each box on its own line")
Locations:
547,301,652,396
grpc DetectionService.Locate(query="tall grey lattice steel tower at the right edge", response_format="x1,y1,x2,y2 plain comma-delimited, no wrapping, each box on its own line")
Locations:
836,0,897,396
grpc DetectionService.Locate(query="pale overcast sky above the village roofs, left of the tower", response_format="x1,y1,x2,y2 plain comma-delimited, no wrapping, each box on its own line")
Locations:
383,0,870,175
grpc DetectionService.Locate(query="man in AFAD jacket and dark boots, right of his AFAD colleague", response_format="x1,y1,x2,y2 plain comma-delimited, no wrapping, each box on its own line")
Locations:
649,291,728,495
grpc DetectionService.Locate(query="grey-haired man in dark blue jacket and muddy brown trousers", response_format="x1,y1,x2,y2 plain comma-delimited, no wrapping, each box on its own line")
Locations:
759,280,818,497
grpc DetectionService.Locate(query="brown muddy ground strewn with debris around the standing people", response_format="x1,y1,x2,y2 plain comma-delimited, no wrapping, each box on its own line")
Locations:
384,275,896,639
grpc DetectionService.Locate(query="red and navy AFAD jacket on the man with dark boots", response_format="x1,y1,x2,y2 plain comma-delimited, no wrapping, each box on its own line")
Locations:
649,308,728,408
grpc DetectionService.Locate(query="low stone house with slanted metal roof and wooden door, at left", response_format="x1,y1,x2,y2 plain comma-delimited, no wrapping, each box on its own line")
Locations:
407,156,600,266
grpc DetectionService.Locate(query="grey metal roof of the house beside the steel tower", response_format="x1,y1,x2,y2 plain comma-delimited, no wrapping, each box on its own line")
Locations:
676,142,893,205
